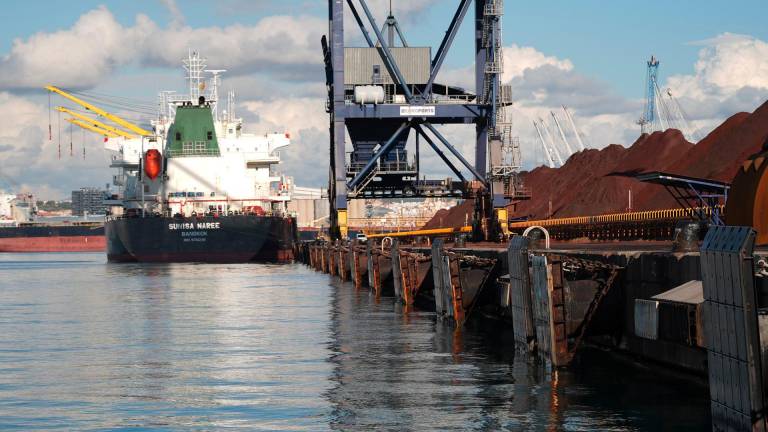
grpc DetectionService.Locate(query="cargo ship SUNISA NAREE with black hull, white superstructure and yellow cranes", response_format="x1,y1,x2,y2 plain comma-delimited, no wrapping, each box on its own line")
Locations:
48,52,297,262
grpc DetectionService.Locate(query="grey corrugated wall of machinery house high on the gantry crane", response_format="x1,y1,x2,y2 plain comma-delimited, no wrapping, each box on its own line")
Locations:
344,47,432,85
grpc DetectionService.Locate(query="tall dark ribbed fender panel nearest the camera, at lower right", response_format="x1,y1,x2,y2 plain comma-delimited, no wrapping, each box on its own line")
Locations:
701,226,768,430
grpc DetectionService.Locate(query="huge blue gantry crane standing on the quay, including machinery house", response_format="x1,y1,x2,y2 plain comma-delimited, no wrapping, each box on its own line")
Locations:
321,0,530,238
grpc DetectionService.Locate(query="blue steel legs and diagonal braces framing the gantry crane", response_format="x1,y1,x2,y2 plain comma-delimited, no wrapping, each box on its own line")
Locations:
323,0,503,236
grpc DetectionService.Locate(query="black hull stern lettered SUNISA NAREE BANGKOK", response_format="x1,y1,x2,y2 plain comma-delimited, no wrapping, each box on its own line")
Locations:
104,215,297,263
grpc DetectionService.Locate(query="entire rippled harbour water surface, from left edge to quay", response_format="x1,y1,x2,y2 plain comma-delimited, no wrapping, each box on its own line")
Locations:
0,254,709,430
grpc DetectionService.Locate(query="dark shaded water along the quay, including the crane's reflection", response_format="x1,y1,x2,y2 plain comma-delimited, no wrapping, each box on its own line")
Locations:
326,283,709,430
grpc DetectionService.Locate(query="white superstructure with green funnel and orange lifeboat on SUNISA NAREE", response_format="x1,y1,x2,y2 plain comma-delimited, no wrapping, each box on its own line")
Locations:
105,52,292,216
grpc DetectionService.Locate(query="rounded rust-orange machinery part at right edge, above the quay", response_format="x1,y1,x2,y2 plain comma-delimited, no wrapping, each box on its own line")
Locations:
725,147,768,245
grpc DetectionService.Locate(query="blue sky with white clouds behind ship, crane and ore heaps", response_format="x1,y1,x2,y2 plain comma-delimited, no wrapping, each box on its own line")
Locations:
0,0,768,199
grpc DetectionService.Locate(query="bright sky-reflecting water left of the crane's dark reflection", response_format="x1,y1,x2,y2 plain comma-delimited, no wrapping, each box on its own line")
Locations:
0,255,331,430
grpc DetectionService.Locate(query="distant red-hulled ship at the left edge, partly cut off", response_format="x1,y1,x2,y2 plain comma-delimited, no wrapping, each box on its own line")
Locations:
0,193,106,253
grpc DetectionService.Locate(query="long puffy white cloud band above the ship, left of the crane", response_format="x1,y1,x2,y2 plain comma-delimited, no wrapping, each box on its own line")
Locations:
0,6,327,89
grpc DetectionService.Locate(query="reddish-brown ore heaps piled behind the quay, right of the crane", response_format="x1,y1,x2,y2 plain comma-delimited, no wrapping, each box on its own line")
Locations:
425,98,768,228
